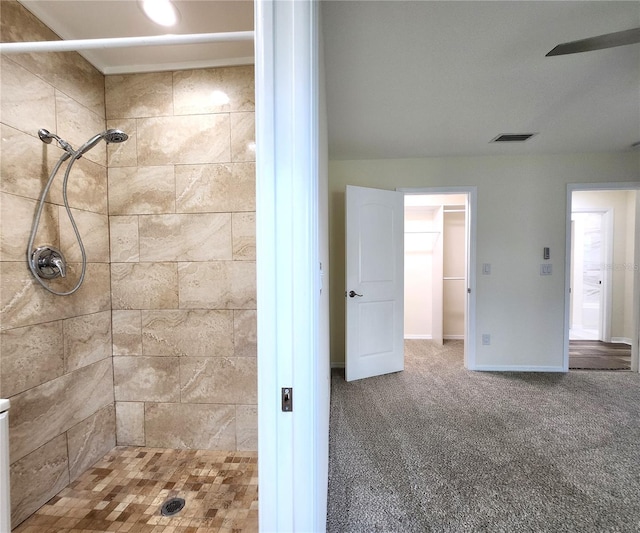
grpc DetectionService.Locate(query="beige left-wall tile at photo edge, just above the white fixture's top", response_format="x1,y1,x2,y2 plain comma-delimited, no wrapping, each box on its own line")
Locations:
0,320,64,398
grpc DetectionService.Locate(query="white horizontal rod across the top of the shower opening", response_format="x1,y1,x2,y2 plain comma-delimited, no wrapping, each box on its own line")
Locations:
0,31,255,54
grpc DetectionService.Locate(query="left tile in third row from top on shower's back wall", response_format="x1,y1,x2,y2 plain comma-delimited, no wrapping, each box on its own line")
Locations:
109,166,176,215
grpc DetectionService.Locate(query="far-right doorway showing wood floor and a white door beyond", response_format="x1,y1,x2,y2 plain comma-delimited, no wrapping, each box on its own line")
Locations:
565,183,640,371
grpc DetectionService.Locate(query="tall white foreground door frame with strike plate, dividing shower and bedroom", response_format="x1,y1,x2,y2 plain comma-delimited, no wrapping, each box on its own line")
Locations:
255,0,329,532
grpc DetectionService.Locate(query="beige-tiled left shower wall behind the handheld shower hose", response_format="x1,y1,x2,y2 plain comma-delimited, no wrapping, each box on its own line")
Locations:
0,0,116,525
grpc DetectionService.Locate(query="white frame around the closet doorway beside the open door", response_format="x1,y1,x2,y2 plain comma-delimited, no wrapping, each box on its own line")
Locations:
396,186,478,370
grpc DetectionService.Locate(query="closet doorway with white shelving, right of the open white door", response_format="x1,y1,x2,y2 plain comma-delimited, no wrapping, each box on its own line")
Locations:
398,187,476,370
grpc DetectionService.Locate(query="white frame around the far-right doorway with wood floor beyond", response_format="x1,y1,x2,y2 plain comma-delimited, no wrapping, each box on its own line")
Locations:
563,181,640,372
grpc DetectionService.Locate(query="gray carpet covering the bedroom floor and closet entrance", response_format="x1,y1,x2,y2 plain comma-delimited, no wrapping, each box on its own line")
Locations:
327,341,640,533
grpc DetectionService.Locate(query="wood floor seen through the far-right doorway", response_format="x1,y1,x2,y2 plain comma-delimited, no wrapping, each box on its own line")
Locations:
569,340,631,370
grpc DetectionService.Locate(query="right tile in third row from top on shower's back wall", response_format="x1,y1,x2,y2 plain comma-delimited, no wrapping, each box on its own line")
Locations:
176,163,256,213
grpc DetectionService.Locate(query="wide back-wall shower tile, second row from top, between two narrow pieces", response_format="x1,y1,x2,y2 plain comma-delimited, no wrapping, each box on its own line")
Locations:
137,114,231,166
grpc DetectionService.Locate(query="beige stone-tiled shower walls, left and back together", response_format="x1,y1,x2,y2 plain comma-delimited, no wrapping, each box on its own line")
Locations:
0,0,257,527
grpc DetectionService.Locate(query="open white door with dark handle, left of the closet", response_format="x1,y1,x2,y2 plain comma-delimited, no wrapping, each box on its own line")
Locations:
345,186,404,381
